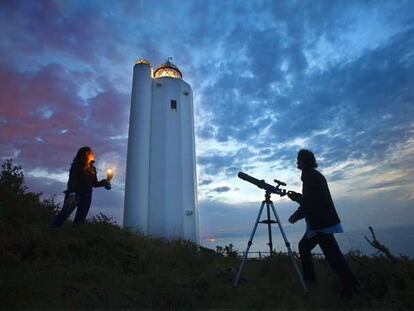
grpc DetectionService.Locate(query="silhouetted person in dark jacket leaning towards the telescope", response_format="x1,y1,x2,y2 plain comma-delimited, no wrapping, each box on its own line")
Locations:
287,149,359,297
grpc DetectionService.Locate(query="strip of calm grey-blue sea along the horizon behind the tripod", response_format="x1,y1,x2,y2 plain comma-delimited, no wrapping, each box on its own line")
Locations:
200,225,414,259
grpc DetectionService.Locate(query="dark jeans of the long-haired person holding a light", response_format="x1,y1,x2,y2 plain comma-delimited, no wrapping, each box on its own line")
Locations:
53,192,92,227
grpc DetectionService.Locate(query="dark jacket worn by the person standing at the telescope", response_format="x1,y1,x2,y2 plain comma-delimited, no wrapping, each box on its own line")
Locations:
292,169,341,230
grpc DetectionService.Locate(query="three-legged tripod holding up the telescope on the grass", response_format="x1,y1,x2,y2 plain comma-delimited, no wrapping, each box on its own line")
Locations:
233,191,308,292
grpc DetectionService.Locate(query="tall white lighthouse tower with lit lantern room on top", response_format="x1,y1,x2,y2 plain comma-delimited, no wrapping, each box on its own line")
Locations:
124,60,199,243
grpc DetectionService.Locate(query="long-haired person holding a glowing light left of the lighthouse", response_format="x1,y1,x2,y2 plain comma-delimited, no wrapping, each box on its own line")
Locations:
53,147,111,227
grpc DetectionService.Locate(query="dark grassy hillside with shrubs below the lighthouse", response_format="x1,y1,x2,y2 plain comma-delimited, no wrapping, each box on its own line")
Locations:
0,160,414,310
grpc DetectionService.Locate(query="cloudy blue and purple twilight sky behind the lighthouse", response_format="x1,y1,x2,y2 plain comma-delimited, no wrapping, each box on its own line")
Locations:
0,0,414,250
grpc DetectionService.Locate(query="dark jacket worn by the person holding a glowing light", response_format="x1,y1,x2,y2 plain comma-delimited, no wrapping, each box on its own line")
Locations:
65,163,106,193
